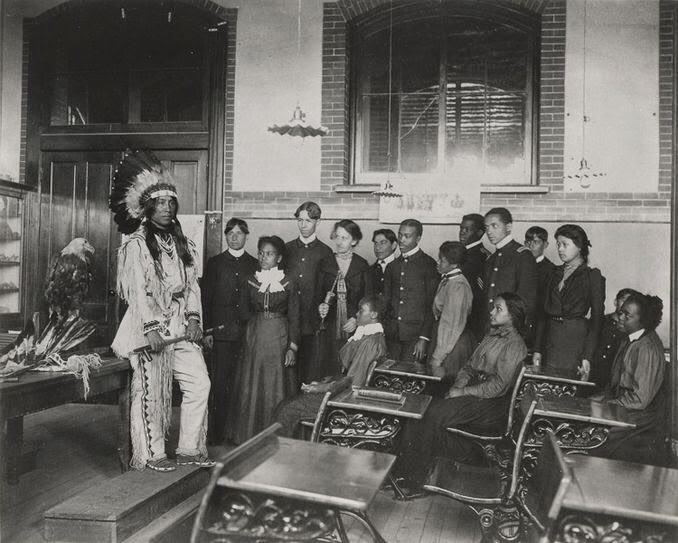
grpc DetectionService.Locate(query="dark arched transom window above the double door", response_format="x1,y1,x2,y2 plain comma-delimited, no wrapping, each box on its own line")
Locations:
40,2,210,126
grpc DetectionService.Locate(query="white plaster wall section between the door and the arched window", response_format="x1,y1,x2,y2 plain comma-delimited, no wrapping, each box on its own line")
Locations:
219,0,322,191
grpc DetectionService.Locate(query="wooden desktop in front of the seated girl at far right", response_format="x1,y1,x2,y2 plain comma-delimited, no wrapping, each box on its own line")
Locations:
534,397,636,428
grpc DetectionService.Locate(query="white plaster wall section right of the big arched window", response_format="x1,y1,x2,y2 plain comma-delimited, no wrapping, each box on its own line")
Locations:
565,0,659,193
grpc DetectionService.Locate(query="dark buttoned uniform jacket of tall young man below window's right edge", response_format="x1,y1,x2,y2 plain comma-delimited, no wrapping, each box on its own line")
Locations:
484,240,539,323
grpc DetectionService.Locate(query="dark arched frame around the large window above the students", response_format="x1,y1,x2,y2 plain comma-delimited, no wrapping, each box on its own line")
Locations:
348,3,541,189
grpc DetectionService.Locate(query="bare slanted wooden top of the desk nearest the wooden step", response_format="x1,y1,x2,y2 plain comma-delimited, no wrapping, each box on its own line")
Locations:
219,437,395,511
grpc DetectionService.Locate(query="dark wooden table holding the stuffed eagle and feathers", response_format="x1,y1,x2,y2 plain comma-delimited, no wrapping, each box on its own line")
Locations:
0,358,130,484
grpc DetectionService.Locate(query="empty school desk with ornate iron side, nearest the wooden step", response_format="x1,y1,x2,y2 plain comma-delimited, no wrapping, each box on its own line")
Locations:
191,424,395,543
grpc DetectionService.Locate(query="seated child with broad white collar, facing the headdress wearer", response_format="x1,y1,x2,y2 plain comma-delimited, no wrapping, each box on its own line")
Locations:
273,297,386,437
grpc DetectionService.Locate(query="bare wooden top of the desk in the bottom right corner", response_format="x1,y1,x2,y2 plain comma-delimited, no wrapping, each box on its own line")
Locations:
563,455,678,526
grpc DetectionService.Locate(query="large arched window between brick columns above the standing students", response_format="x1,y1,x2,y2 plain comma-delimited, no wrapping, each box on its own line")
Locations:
351,2,539,184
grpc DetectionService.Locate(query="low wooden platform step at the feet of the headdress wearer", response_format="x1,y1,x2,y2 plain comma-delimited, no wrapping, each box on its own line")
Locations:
44,466,210,543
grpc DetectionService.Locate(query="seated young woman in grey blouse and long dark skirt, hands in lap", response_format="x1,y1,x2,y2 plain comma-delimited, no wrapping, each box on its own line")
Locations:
399,292,527,489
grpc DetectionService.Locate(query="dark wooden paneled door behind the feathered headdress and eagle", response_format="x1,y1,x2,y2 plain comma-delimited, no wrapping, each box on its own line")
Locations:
35,150,207,344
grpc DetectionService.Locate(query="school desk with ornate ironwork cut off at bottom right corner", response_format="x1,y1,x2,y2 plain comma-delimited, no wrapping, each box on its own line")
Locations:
554,455,678,543
